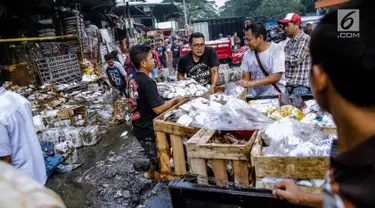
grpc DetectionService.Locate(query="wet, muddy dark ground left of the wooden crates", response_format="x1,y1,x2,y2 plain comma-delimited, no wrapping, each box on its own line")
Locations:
46,124,154,208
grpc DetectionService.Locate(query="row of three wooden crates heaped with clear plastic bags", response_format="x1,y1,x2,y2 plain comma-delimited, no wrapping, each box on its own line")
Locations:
154,88,337,193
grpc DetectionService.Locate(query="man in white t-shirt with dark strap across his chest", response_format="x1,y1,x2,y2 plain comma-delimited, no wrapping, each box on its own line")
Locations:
236,23,285,97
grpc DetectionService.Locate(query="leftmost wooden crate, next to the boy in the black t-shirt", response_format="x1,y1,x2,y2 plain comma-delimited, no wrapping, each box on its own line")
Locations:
153,99,199,180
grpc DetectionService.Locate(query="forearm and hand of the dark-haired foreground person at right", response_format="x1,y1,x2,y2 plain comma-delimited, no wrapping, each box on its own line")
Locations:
272,180,323,208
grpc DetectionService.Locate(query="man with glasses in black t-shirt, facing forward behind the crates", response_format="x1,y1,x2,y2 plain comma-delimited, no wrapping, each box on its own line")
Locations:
177,32,220,89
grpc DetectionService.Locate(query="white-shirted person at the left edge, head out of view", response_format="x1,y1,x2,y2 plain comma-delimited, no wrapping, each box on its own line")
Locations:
0,70,47,185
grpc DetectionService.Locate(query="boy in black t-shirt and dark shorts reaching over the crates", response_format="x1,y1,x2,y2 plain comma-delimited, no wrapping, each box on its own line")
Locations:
129,45,183,181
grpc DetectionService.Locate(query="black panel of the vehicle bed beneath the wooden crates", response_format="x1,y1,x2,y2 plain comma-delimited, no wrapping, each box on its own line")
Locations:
169,179,308,208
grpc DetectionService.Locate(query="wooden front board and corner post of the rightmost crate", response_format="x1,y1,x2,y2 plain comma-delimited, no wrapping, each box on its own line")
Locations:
251,131,329,179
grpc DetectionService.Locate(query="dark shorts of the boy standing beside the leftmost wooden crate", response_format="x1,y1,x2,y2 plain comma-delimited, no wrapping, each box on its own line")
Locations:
136,135,160,172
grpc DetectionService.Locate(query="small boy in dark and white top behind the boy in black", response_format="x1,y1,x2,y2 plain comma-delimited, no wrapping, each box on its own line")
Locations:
104,53,128,120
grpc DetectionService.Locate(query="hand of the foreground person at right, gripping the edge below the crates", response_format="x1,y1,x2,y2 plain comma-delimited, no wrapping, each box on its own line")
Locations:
272,180,307,205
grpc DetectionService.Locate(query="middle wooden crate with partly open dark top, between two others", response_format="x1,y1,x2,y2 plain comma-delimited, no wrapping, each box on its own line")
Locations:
187,129,256,186
